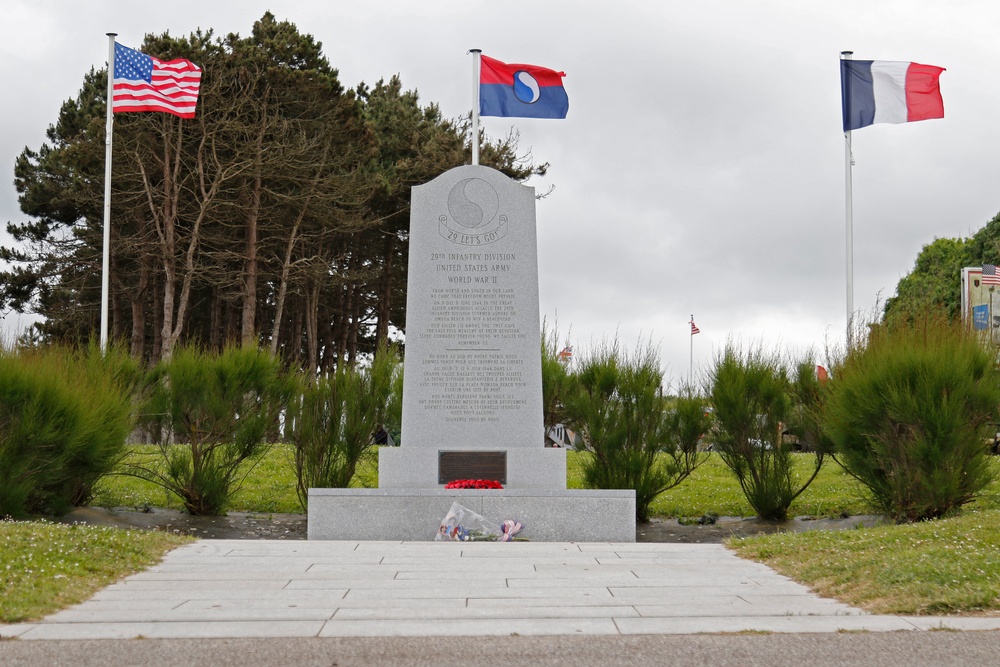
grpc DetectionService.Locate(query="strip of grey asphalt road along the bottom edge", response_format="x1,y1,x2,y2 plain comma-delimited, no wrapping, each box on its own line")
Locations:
0,631,1000,667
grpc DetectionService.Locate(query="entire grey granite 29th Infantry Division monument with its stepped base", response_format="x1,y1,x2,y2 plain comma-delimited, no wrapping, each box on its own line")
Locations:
309,165,635,541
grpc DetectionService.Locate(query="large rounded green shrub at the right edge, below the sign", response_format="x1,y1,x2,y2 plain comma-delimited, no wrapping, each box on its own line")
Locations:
824,318,1000,521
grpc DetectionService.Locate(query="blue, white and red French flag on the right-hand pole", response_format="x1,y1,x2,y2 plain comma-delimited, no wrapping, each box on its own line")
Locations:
840,60,944,132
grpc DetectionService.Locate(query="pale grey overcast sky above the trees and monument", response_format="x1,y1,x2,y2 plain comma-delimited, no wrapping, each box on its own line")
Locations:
0,0,1000,384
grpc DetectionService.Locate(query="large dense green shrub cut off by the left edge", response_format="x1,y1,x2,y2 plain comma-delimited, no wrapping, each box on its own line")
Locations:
0,347,137,516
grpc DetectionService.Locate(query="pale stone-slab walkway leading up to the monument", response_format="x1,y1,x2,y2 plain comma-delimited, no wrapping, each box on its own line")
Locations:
0,540,1000,639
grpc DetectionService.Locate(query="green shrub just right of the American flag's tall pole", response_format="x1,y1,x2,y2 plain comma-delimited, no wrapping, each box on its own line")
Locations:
127,346,291,514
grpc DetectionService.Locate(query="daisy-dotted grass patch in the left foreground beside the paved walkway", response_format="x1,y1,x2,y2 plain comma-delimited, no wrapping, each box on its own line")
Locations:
0,521,193,623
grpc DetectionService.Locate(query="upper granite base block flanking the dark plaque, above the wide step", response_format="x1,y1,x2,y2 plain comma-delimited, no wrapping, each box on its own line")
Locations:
378,445,566,488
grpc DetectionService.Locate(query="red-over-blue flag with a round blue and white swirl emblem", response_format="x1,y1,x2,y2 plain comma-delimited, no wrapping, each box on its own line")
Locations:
479,56,569,118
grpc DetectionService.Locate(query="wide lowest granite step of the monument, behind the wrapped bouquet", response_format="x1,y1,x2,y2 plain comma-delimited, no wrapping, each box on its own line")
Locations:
308,489,635,542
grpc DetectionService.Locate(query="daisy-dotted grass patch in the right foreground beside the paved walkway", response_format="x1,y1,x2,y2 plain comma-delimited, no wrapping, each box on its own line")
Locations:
728,509,1000,615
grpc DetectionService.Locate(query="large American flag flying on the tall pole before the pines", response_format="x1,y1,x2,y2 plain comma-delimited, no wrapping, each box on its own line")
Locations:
111,42,201,118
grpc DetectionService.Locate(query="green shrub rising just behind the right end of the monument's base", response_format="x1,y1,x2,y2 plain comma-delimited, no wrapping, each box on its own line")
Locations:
565,342,704,522
